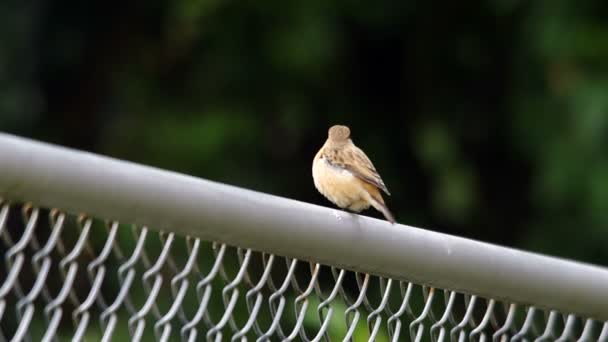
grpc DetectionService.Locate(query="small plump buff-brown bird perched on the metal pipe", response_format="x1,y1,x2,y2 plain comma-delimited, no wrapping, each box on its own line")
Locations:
312,125,395,223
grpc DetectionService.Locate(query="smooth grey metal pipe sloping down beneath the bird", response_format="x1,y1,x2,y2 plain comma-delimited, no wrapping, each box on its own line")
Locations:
0,133,608,321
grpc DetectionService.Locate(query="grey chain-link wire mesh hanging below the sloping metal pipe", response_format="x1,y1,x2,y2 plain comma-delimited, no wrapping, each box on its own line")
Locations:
0,201,608,341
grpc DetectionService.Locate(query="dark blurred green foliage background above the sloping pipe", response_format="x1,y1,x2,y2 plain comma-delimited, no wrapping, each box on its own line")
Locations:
0,0,608,265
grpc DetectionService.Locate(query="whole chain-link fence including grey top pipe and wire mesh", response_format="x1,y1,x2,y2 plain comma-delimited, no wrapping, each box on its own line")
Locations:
0,134,608,341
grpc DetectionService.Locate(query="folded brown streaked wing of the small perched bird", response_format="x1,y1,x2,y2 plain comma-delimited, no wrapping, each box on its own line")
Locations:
328,146,391,196
